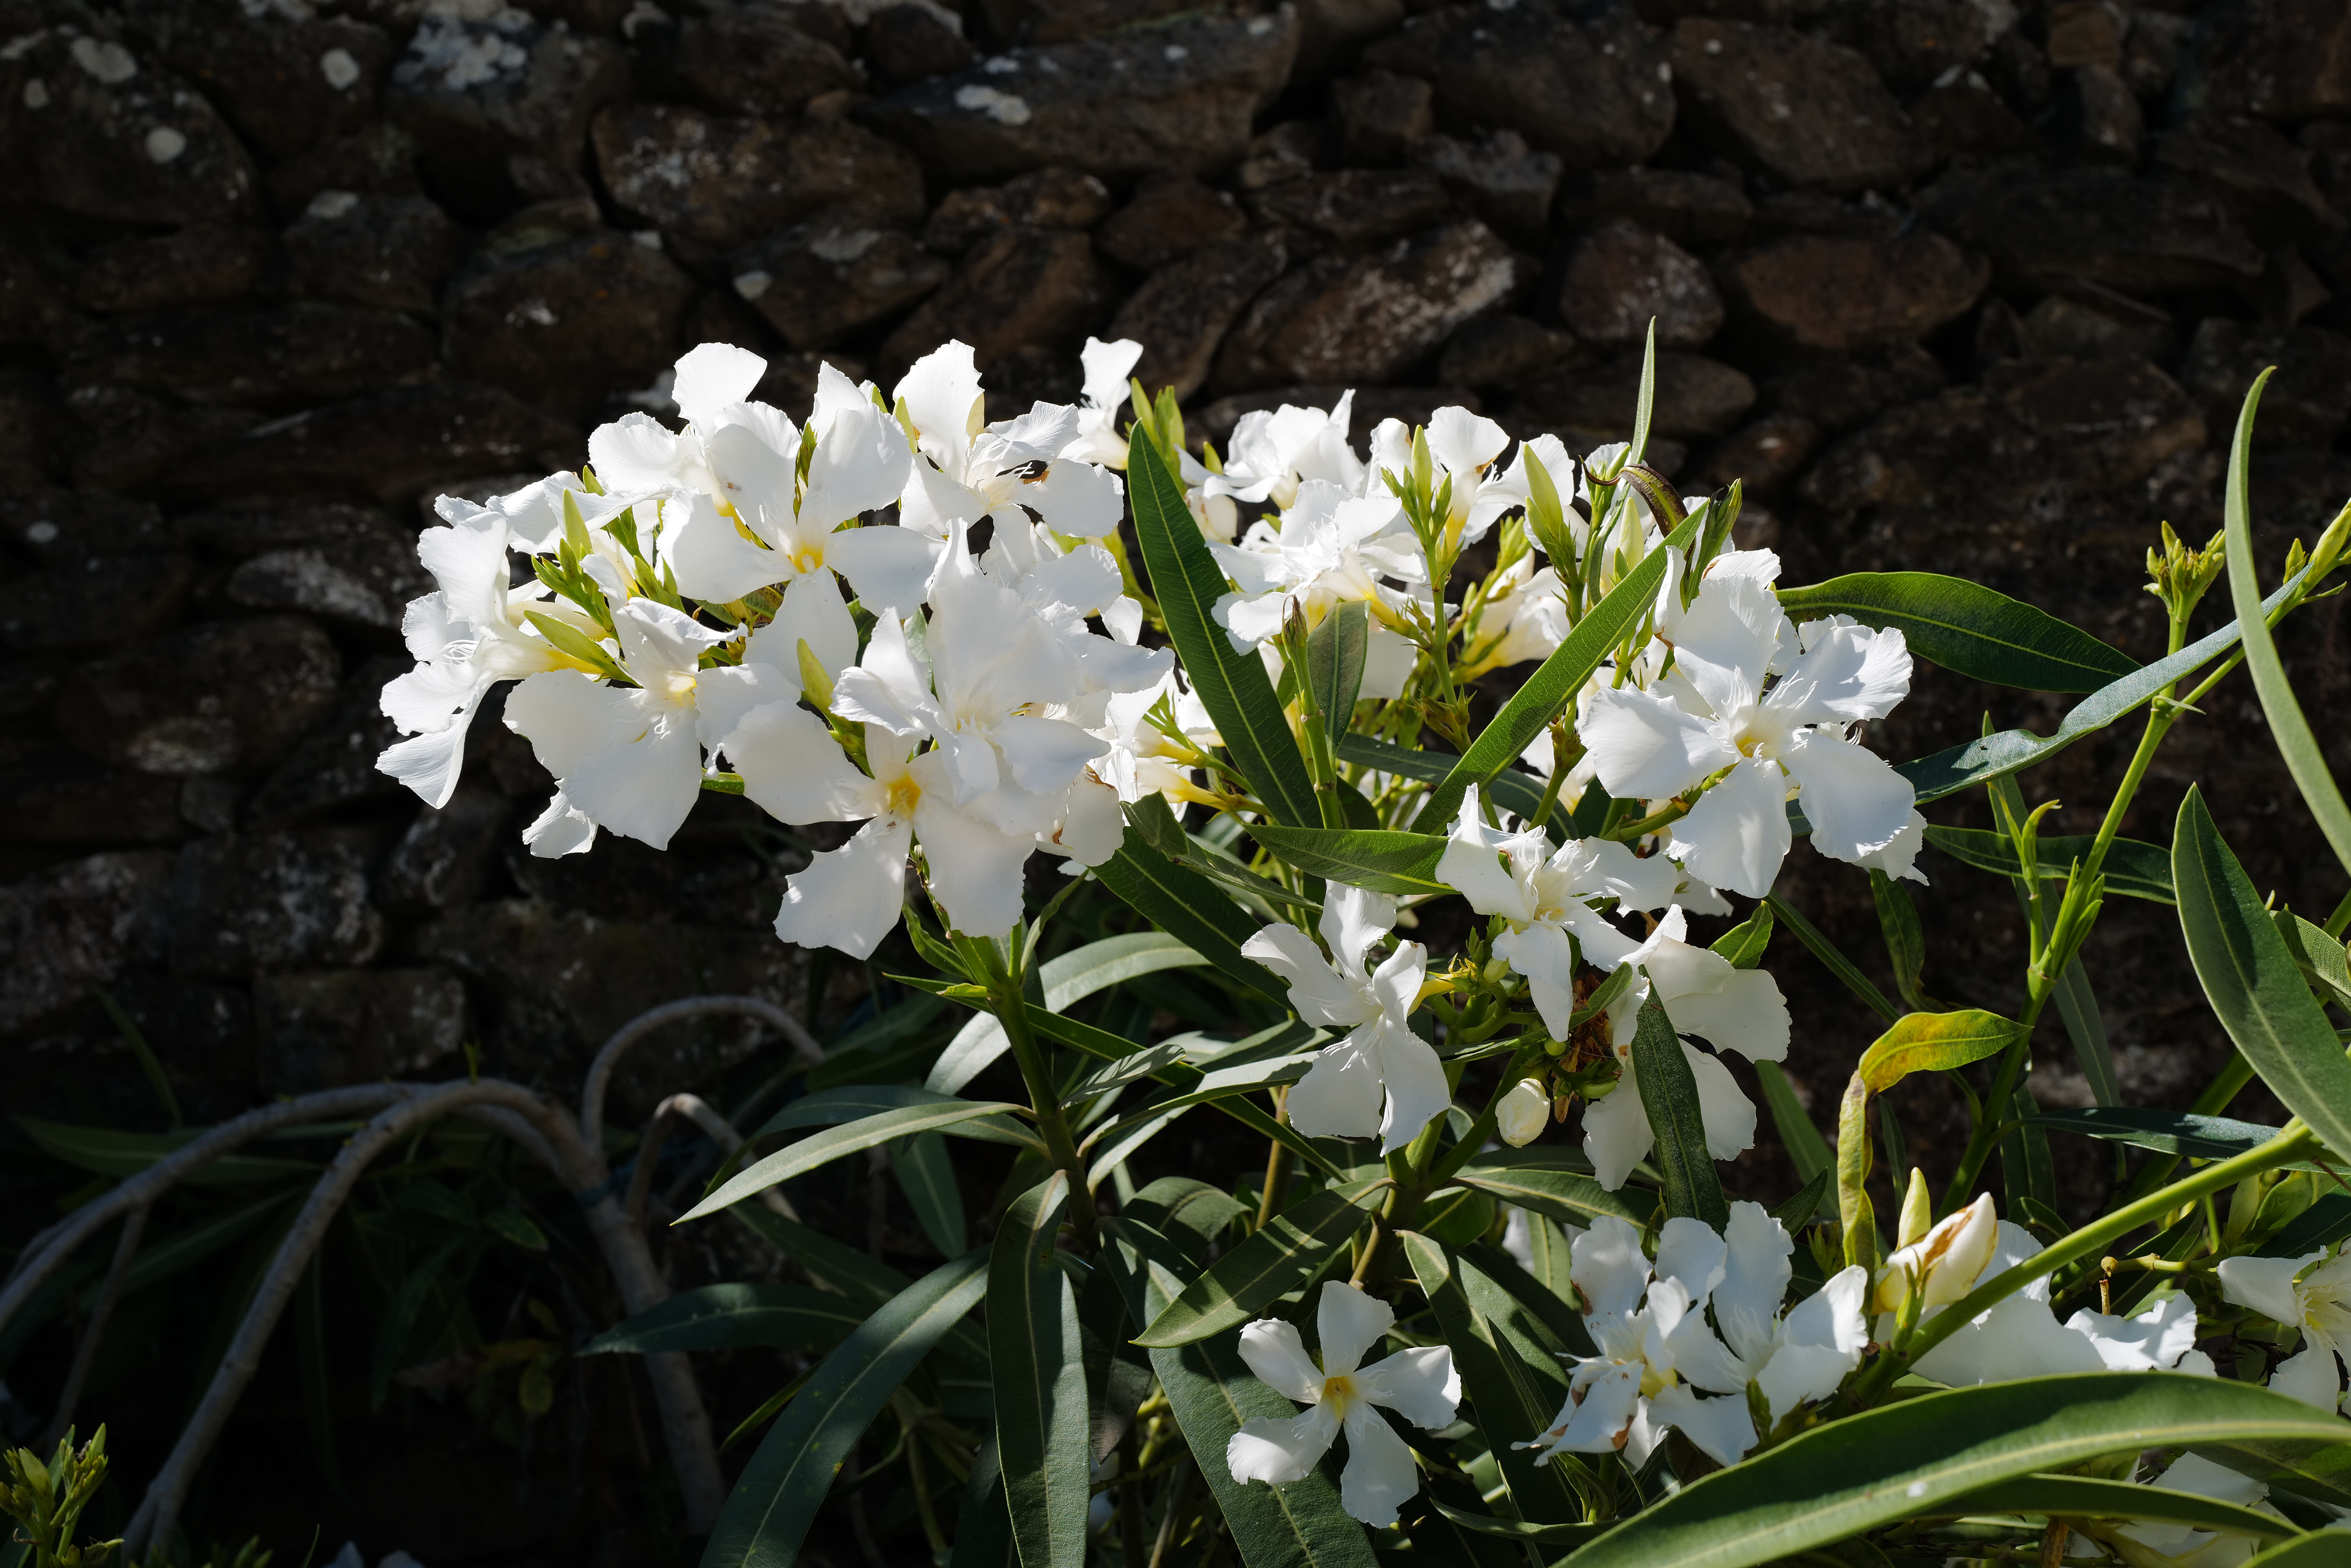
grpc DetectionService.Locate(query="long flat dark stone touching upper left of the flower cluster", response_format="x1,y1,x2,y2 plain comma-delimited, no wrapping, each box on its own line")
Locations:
162,383,581,505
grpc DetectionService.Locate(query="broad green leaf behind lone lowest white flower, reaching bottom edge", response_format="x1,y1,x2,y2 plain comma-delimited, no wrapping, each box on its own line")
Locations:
1140,1260,1378,1568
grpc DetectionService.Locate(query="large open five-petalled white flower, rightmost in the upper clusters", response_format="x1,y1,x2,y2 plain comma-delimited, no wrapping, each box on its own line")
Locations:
1575,574,1916,898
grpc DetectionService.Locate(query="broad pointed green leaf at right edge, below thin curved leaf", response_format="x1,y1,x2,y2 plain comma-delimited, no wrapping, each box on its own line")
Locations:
2172,788,2351,1154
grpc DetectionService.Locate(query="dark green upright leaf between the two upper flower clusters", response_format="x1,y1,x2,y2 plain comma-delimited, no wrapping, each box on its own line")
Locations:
1126,423,1321,827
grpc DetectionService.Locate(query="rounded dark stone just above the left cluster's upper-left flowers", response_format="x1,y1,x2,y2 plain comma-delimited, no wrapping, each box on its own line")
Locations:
442,230,694,416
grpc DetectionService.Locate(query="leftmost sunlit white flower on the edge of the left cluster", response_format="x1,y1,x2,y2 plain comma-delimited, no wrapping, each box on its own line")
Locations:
376,512,578,809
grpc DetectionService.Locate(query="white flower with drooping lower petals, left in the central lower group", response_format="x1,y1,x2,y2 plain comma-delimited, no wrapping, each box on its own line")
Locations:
1241,881,1453,1154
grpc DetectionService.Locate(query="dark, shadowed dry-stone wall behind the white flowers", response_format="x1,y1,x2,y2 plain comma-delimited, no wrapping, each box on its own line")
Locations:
0,0,2351,1180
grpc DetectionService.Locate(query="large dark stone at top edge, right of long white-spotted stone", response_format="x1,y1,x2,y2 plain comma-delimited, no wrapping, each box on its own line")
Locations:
1363,0,1674,169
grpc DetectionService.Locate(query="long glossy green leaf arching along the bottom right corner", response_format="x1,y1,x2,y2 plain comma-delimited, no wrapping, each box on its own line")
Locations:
1566,1373,2344,1568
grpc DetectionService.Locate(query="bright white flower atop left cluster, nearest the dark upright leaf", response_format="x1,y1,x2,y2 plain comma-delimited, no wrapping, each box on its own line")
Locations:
896,343,1126,538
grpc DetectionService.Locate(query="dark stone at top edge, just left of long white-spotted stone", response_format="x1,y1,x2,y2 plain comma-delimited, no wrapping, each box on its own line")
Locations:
630,0,858,117
